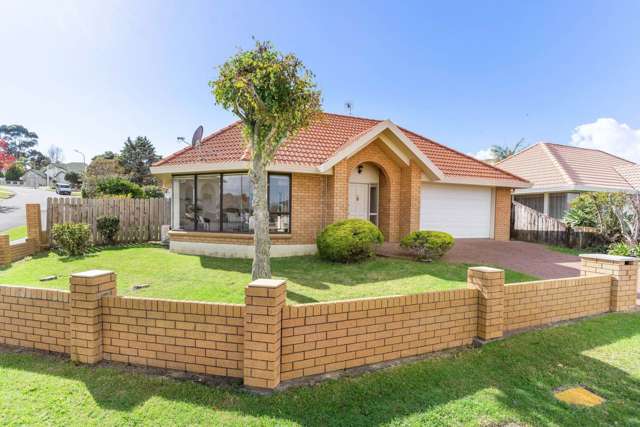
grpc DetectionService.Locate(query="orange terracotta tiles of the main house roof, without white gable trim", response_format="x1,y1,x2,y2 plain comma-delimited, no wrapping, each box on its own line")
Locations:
154,113,525,182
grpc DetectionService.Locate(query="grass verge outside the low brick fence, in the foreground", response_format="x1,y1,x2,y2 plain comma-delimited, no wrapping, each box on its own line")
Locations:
0,313,640,427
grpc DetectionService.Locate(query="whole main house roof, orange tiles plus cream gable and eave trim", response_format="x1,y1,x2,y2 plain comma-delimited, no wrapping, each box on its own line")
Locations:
152,113,529,187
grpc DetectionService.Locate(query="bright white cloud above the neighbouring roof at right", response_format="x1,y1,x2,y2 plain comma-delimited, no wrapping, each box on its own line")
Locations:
571,118,640,163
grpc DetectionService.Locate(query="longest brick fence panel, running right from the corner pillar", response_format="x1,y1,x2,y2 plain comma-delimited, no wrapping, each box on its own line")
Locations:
281,289,478,380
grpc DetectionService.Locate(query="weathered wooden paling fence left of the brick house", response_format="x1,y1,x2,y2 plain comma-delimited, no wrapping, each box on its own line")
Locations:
47,197,171,243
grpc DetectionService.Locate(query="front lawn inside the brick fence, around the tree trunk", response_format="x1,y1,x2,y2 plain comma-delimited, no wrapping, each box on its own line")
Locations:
0,245,534,304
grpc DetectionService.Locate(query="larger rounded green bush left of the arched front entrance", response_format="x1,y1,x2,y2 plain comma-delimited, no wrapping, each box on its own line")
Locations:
316,219,384,262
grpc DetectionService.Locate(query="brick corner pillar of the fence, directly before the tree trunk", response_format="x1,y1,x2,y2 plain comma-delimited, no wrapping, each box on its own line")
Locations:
244,279,287,389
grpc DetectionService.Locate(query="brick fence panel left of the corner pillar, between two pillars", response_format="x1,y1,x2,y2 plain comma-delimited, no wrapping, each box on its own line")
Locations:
102,296,244,377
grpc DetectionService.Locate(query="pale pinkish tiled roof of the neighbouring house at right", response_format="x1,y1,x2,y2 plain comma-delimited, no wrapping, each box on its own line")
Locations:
497,142,640,193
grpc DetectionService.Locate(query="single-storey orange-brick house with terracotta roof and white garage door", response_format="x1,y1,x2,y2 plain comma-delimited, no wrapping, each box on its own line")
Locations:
151,113,530,257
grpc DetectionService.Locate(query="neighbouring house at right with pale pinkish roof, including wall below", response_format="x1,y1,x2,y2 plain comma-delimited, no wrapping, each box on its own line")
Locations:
496,142,640,219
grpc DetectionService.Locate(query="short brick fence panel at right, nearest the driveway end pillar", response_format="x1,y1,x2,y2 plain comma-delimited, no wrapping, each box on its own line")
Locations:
504,275,611,331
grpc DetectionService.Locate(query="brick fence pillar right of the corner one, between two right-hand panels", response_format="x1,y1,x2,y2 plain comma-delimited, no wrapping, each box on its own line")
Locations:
467,267,504,341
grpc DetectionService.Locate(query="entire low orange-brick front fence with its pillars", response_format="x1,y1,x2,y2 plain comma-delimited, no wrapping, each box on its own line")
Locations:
0,255,638,389
